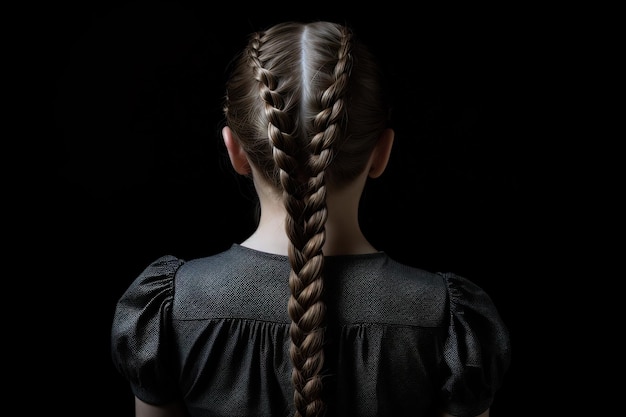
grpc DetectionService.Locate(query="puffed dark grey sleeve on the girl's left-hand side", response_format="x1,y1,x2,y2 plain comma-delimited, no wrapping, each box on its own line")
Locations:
111,255,184,405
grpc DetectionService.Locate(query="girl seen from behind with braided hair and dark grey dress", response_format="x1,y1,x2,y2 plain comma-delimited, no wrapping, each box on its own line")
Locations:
112,21,510,417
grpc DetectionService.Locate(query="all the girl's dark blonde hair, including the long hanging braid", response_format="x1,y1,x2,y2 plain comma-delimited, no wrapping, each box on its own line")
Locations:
224,21,389,416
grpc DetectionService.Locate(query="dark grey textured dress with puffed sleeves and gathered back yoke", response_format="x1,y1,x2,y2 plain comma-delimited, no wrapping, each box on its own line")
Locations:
111,244,510,417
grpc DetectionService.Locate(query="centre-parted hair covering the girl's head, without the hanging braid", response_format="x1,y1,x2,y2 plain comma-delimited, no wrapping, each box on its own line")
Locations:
225,22,389,187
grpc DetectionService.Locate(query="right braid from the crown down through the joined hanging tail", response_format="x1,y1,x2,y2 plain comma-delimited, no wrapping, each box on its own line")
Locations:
285,25,351,416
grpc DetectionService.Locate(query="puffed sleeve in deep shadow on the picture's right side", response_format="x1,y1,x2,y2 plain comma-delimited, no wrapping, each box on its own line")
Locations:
441,273,511,416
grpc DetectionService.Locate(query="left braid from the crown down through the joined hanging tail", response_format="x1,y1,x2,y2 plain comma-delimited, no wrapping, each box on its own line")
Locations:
248,28,325,417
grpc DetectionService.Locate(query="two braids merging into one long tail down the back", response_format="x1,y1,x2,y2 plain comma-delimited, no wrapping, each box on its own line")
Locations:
249,26,349,417
